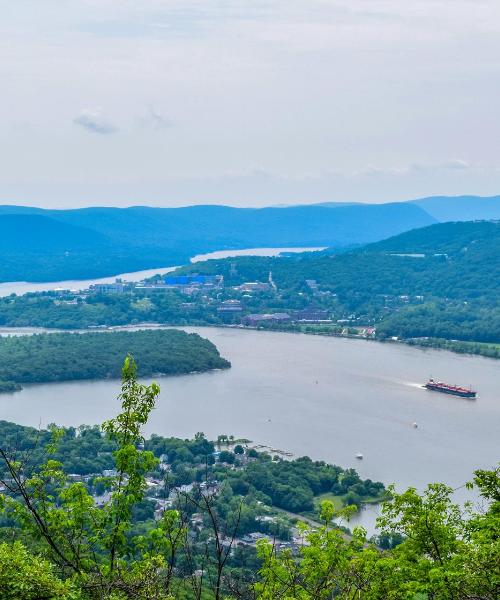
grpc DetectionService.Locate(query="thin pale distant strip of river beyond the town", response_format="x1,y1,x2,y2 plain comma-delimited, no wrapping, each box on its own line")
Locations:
0,248,324,297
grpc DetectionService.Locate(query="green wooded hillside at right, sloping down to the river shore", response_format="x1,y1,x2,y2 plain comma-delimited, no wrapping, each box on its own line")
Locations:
171,222,500,352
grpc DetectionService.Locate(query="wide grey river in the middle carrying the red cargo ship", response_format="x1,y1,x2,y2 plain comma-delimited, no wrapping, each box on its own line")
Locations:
0,327,500,529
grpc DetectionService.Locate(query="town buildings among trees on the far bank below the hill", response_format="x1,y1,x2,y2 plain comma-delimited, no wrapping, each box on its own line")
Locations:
39,264,424,339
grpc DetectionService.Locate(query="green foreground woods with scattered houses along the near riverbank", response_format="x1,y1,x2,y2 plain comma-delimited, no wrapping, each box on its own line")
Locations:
0,359,500,600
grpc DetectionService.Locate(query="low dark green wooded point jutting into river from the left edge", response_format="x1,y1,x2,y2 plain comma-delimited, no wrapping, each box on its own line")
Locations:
0,330,230,391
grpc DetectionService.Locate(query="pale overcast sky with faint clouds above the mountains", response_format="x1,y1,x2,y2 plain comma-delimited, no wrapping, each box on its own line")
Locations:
0,0,500,208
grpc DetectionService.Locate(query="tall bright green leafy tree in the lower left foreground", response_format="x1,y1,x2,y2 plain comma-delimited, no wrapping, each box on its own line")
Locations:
0,356,185,599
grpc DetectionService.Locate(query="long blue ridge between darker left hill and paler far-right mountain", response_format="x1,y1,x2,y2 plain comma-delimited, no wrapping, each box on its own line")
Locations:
0,202,435,252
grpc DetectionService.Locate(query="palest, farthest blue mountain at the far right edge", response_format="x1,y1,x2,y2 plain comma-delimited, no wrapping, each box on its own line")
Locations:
412,196,500,222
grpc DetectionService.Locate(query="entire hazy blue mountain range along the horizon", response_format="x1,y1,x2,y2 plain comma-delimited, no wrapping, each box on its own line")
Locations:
0,196,500,281
